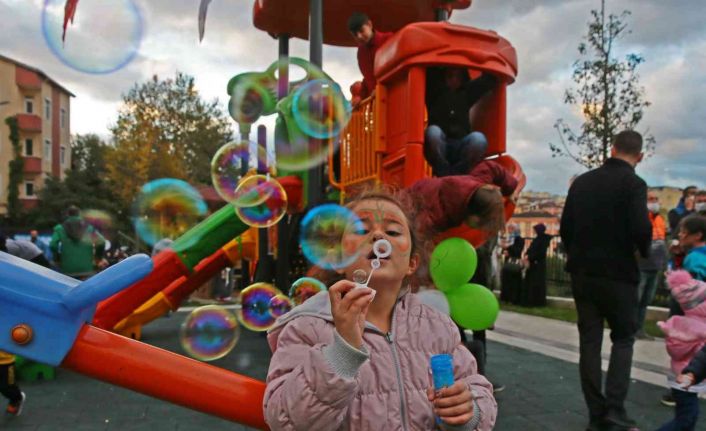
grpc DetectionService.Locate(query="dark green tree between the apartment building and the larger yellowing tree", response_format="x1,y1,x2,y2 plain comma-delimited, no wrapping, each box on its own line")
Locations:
28,134,123,228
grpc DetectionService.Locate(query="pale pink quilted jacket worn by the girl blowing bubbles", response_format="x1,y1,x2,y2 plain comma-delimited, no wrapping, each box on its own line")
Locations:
264,292,497,431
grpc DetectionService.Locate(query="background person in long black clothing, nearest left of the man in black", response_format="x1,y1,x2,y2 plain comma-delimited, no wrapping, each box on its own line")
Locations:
522,223,552,307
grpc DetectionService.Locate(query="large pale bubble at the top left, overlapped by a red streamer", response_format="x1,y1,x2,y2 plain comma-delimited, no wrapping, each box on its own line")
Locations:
42,0,143,74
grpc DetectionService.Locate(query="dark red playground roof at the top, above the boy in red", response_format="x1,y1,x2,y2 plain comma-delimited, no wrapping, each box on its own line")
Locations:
253,0,471,46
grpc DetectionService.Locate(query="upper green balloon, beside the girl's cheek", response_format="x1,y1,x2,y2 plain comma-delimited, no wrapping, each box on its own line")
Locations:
429,238,478,291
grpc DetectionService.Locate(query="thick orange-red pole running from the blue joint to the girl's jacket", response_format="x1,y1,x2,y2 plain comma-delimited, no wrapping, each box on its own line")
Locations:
61,325,269,430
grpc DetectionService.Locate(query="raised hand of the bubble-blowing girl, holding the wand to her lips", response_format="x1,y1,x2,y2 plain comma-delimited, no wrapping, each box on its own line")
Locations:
328,280,374,349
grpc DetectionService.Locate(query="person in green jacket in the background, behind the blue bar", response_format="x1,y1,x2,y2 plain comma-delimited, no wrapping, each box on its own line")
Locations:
49,205,105,279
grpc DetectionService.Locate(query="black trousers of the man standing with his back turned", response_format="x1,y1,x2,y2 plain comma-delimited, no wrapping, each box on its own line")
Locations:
571,274,638,418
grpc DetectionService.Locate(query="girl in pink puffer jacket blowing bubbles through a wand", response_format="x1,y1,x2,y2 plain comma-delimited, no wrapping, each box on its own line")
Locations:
264,192,497,430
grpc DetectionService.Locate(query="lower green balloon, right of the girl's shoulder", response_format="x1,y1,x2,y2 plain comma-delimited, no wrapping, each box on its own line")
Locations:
445,284,500,331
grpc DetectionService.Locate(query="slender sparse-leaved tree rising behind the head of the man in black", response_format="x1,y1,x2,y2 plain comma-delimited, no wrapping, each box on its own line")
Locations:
549,0,655,169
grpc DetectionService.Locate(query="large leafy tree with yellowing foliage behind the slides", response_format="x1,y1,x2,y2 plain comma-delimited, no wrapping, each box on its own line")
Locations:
107,72,233,206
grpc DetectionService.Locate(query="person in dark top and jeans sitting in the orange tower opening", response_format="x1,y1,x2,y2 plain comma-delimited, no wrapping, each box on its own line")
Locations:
424,67,497,177
